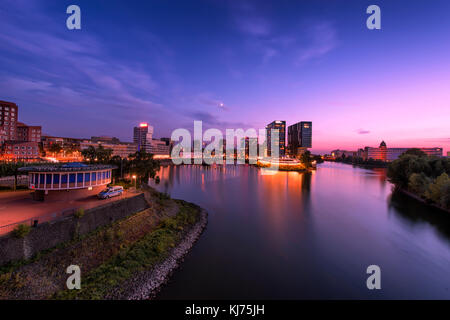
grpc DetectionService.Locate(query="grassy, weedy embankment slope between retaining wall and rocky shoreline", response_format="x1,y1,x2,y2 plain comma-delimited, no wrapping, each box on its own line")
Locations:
0,187,206,299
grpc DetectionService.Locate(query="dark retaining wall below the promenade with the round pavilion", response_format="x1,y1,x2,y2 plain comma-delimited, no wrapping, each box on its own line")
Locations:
0,194,148,265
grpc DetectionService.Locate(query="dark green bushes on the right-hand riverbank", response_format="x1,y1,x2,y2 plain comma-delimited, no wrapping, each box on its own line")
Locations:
387,149,450,210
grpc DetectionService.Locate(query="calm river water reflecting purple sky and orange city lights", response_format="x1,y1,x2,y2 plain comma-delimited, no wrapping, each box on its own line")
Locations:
150,163,450,299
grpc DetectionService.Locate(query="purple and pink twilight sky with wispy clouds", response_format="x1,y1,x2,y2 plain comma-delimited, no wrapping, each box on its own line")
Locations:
0,0,450,154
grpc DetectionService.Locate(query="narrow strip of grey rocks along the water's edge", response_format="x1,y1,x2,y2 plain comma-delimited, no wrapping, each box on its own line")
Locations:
105,209,208,300
